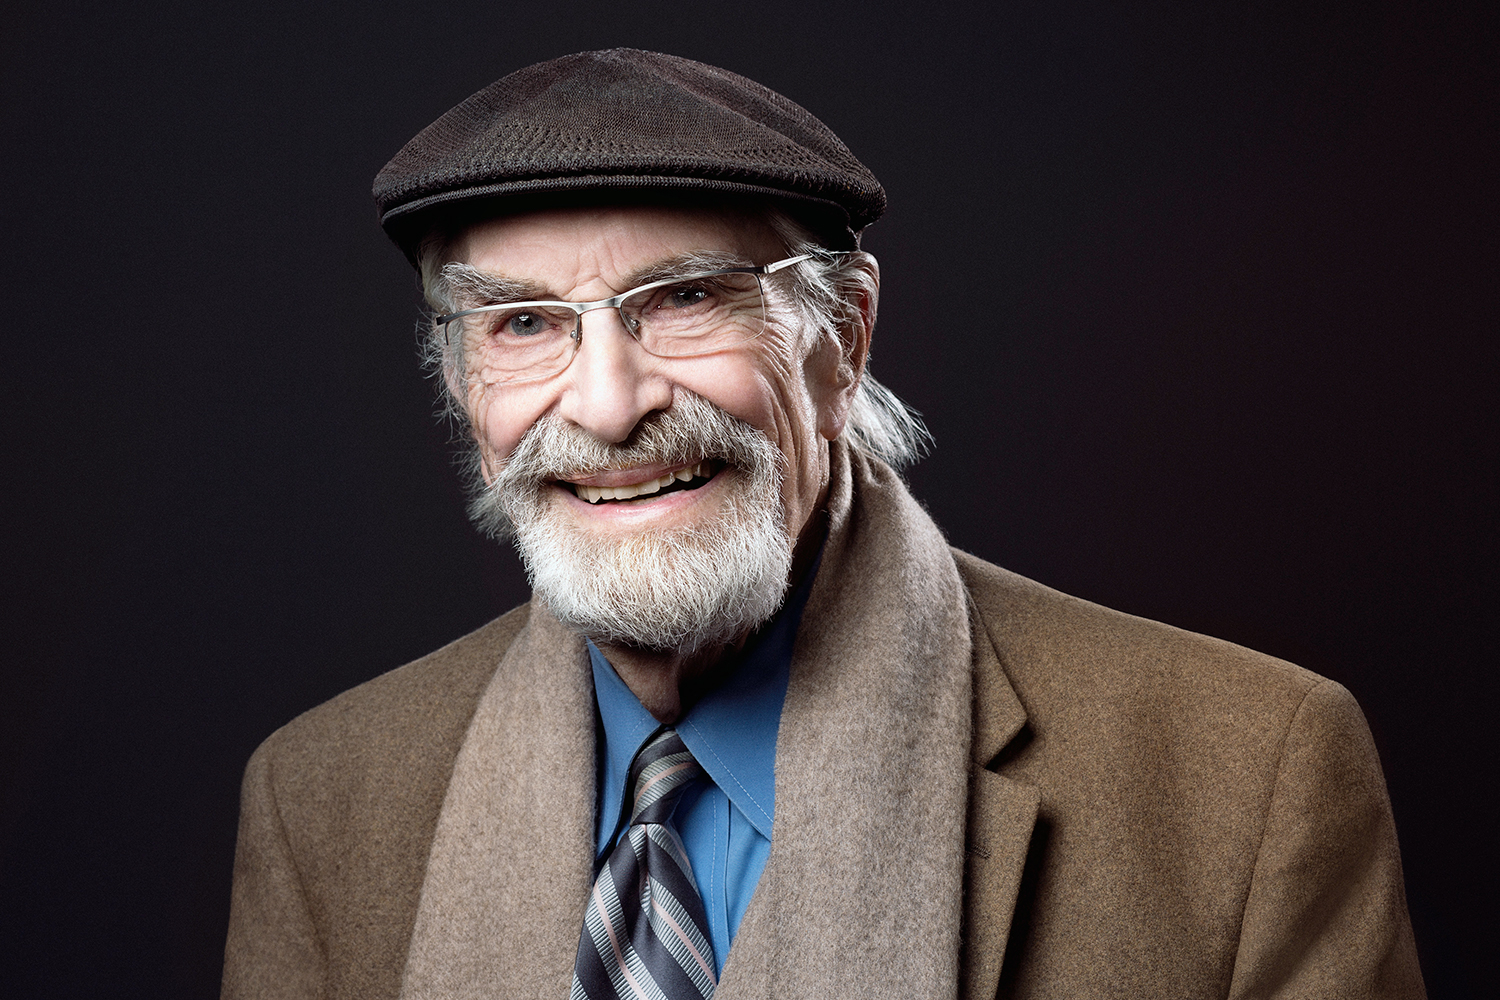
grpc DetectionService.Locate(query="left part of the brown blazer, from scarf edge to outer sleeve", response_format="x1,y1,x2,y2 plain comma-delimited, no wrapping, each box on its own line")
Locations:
225,606,530,997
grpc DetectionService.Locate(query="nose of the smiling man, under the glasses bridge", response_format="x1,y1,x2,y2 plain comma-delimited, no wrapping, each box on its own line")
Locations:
558,309,672,444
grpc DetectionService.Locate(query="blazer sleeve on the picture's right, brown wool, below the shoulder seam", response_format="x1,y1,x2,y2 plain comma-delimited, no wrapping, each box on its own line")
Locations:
1229,681,1427,1000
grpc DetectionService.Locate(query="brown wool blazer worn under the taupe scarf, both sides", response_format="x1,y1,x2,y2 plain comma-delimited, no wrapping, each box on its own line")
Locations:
224,552,1425,1000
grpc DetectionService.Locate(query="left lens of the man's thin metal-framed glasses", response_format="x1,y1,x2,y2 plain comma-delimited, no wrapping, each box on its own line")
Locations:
449,303,578,382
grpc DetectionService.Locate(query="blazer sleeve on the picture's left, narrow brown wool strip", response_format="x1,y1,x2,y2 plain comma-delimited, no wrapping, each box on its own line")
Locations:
221,744,327,1000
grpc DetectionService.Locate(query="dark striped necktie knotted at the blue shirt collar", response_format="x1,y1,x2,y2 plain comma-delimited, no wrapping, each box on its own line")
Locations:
572,729,719,1000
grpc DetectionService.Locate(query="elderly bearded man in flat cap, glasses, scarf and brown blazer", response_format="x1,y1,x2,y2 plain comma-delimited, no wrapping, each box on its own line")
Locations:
224,49,1422,1000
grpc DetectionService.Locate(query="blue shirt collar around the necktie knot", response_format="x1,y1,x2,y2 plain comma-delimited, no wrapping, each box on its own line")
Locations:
588,553,822,847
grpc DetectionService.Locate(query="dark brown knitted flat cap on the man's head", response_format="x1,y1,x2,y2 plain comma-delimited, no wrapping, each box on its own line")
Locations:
375,48,885,259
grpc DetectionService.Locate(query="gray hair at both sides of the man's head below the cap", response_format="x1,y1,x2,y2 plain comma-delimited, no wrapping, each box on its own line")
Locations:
417,205,933,472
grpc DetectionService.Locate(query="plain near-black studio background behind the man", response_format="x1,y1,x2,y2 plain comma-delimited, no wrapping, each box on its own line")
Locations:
0,1,1500,997
